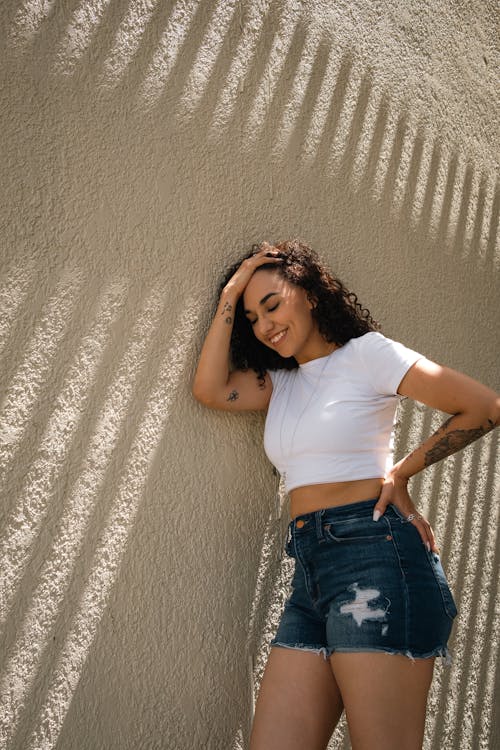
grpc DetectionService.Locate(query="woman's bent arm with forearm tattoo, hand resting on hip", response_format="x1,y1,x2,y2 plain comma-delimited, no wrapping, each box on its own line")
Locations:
374,359,500,550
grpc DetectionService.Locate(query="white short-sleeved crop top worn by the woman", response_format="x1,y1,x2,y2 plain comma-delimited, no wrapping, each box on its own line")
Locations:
264,331,422,492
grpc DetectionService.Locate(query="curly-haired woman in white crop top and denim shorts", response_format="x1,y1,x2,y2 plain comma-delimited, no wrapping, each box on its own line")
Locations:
193,240,500,750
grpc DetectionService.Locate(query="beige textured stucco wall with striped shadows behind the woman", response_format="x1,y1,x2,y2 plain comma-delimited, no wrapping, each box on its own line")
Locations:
0,0,500,750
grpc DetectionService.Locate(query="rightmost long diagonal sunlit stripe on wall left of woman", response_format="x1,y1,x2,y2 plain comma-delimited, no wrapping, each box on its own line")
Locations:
21,299,198,750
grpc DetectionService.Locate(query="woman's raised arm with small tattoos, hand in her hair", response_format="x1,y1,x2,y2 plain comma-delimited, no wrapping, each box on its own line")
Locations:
192,247,281,411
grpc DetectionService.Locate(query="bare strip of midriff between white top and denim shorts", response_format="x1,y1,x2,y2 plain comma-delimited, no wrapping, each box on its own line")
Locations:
290,477,384,519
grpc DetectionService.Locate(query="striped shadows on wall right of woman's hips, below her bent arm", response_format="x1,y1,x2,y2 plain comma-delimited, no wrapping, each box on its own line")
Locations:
390,399,500,748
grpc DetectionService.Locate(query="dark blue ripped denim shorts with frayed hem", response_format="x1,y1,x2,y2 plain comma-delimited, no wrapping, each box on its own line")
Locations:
271,498,457,663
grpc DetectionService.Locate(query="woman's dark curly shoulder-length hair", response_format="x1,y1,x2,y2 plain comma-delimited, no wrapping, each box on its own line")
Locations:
219,239,380,379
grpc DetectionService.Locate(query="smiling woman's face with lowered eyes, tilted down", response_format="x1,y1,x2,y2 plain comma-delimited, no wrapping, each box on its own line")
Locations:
243,269,325,362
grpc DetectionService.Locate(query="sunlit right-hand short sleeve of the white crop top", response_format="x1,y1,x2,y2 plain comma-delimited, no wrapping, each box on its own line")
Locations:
358,331,424,396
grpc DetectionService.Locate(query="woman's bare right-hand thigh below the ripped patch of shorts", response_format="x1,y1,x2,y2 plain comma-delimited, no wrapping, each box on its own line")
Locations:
330,653,434,750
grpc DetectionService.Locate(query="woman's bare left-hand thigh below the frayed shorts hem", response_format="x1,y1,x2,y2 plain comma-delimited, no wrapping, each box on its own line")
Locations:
250,646,343,750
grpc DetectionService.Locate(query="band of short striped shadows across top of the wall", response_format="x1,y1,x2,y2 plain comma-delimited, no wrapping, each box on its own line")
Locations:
4,0,500,270
